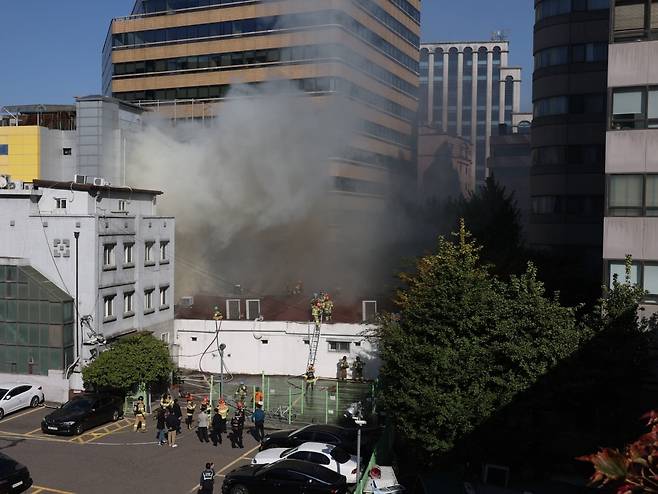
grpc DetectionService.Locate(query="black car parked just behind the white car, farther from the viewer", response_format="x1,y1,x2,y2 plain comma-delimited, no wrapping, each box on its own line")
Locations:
261,424,366,454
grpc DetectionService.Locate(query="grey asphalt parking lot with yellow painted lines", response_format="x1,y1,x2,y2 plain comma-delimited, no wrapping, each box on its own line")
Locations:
0,407,270,494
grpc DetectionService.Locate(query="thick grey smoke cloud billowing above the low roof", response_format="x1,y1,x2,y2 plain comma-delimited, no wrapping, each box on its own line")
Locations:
127,83,386,296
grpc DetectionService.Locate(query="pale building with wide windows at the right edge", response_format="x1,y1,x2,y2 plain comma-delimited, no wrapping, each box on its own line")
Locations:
603,0,658,303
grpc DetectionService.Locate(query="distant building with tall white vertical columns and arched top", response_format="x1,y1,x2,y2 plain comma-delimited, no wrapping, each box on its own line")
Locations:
419,40,521,188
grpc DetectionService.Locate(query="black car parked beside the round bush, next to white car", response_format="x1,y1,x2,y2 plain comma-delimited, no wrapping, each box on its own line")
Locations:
41,393,123,435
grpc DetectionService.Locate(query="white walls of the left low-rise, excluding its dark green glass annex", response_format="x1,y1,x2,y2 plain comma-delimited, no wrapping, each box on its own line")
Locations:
0,180,175,389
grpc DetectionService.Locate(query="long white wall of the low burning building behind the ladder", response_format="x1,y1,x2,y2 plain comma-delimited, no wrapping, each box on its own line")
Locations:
171,319,380,379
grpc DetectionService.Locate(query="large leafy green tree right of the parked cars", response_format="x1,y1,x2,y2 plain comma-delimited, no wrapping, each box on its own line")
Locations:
377,221,585,463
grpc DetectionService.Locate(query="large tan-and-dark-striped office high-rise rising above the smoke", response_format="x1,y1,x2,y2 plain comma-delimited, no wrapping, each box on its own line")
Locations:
103,0,421,206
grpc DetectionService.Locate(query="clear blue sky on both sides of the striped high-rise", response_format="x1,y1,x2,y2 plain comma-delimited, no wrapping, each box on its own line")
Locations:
0,0,533,110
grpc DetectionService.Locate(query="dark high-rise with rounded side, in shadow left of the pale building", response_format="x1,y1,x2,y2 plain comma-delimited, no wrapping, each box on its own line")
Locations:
529,0,609,270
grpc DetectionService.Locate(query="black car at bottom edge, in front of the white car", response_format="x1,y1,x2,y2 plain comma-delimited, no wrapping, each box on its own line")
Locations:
222,460,347,494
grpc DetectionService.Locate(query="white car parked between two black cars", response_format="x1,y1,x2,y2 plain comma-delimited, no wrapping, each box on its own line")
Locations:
251,443,356,484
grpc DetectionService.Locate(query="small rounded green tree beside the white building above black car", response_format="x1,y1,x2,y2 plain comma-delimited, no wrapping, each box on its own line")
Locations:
82,333,174,392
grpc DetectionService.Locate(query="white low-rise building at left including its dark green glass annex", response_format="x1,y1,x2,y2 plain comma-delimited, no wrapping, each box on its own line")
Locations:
0,180,175,389
